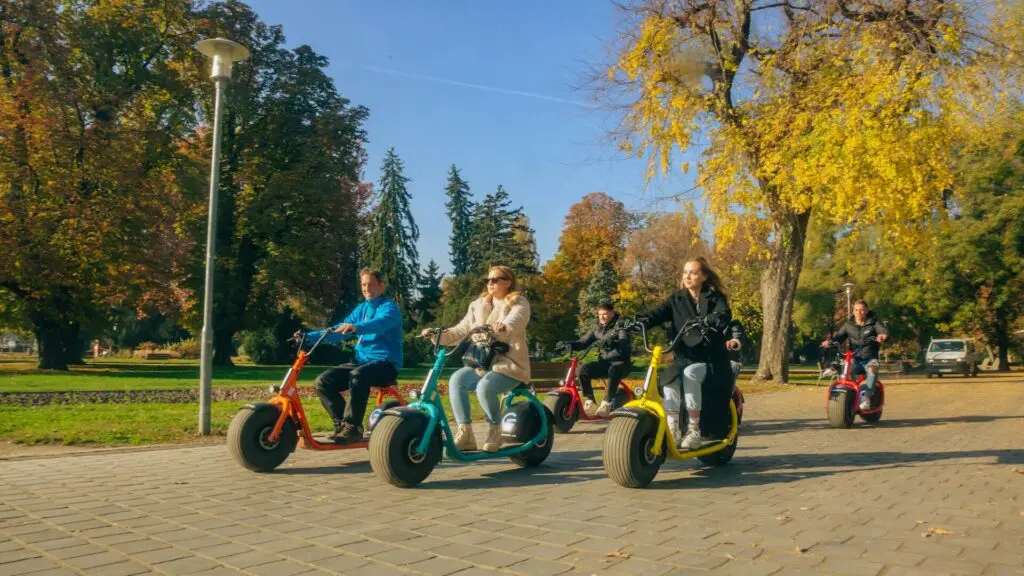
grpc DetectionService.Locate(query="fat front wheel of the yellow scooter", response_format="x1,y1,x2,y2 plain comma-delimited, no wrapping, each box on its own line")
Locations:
601,414,665,488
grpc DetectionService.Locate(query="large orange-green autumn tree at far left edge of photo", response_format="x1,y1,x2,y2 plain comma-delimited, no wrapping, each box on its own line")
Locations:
0,0,196,370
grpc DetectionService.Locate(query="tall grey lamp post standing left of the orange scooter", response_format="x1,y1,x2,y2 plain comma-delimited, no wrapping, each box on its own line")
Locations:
196,38,249,436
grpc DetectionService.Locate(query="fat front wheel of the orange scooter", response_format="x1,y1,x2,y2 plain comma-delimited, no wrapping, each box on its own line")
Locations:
227,402,299,472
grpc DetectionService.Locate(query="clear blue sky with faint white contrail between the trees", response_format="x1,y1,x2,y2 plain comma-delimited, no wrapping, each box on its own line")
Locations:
250,0,692,271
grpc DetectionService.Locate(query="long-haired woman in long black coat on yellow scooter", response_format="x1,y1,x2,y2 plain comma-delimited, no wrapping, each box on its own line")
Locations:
638,257,735,450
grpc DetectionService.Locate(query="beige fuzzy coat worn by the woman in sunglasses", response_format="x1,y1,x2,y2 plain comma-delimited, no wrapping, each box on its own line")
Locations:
441,292,529,382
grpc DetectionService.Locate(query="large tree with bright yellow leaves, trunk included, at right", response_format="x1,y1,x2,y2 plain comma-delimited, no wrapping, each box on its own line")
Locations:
609,0,1024,381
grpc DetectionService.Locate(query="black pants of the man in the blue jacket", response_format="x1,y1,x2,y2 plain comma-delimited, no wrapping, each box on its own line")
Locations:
316,360,398,430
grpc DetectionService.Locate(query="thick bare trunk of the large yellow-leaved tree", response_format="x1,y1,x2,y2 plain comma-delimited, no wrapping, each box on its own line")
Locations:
756,211,811,382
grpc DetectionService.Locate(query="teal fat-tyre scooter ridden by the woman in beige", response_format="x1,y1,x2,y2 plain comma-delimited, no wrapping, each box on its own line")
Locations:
370,326,555,488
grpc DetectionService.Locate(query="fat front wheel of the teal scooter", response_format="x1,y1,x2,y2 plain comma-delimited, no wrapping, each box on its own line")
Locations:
370,414,441,488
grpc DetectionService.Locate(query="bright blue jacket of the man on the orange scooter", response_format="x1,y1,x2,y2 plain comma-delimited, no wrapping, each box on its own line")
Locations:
306,295,402,369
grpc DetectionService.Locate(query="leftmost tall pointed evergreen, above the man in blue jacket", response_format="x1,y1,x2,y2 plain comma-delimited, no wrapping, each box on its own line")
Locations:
367,148,420,313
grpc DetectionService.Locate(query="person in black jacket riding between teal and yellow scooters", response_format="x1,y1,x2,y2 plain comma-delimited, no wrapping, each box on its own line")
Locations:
558,302,633,417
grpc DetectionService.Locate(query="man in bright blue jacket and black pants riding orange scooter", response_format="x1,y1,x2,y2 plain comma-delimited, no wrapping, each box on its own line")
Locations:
306,269,402,444
